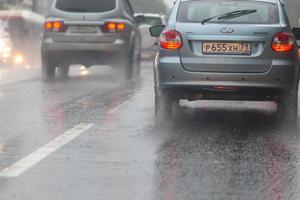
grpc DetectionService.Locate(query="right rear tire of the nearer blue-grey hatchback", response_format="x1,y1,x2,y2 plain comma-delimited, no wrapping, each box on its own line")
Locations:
277,92,298,129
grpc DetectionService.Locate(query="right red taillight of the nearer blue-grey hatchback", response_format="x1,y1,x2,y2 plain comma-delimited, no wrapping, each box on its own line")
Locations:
272,32,295,52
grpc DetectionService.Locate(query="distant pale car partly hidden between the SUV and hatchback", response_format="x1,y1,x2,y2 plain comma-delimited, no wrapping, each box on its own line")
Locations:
134,13,166,50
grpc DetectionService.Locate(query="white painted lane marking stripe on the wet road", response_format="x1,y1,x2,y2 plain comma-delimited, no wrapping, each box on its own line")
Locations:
0,124,94,178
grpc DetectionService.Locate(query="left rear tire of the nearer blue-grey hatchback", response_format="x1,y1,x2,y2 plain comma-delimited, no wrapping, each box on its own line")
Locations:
155,89,173,126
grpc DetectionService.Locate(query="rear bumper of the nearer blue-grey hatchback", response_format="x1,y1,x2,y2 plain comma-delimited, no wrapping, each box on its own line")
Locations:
154,56,298,99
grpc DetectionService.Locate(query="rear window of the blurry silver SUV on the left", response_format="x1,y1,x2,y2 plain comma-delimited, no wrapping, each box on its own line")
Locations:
56,0,116,12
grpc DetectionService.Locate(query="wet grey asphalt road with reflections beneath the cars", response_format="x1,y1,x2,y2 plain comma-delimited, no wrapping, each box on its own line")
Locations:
0,62,300,200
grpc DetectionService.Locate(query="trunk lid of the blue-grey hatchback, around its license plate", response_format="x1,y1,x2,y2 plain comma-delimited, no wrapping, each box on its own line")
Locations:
175,23,281,73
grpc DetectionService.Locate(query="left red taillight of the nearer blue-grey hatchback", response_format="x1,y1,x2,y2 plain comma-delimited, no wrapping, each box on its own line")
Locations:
160,30,183,50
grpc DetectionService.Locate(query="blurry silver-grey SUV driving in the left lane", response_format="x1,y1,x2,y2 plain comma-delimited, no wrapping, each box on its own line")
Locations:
42,0,141,80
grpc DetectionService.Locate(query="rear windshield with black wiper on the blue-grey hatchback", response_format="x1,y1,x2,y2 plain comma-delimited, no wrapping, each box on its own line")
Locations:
177,1,279,24
